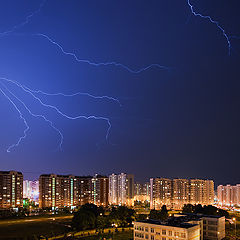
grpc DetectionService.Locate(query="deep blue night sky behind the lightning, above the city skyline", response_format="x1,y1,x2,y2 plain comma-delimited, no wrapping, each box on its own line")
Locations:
0,0,240,184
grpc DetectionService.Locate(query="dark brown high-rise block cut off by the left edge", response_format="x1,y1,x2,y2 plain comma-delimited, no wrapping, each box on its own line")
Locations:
0,171,23,208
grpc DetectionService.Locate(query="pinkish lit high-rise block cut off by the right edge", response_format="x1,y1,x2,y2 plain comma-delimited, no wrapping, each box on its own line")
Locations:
217,184,240,206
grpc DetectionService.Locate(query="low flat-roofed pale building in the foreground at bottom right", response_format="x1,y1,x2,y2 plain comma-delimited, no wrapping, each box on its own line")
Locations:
134,214,225,240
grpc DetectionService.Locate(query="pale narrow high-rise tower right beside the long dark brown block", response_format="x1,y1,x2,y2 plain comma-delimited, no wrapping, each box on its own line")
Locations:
109,173,134,205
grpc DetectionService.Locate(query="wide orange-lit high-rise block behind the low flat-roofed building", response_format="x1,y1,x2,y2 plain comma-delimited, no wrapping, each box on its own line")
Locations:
150,178,214,209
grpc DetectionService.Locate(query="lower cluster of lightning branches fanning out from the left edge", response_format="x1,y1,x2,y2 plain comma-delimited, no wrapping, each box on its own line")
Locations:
0,77,116,152
